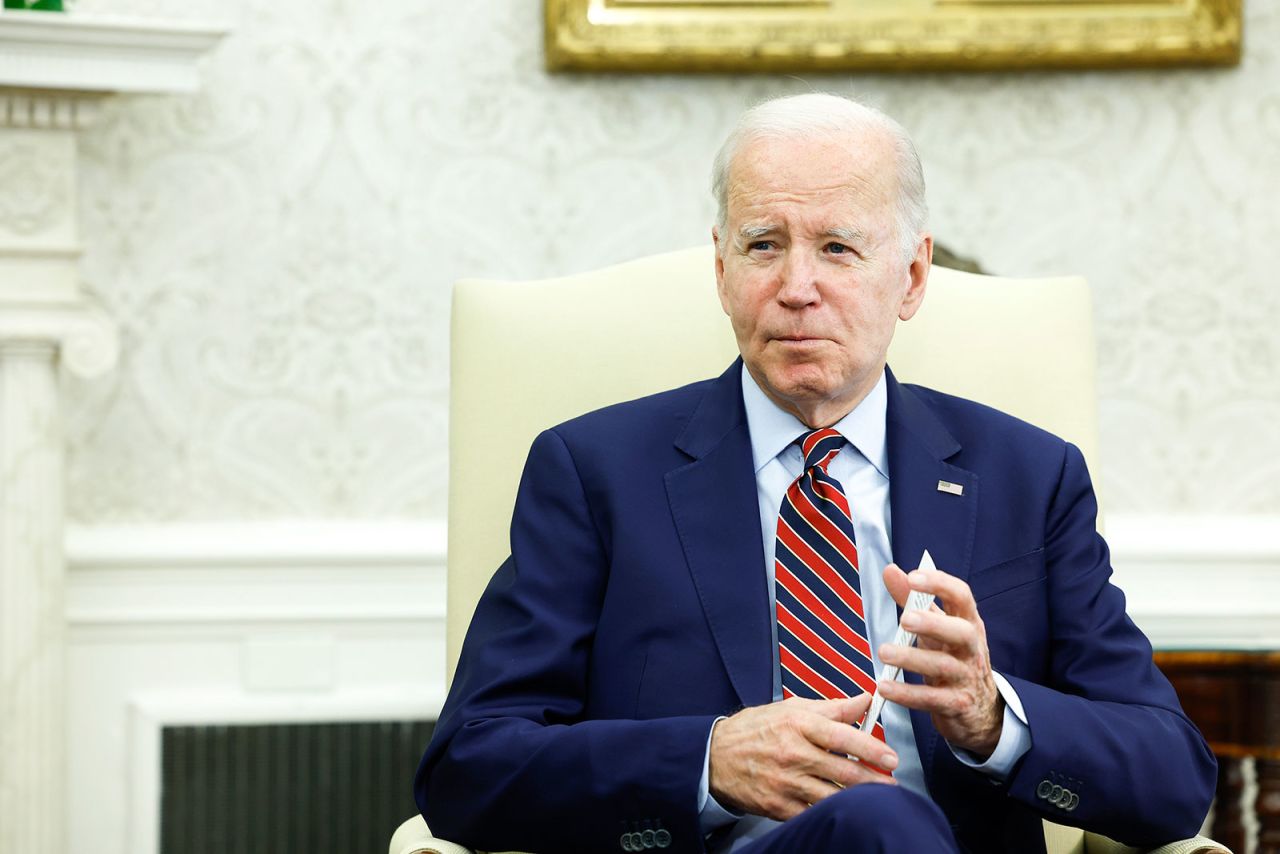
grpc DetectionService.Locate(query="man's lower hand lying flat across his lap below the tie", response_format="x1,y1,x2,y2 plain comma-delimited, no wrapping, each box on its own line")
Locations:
709,694,897,821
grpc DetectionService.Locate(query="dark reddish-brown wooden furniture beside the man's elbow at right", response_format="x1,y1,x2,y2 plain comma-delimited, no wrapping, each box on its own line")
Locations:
1156,650,1280,854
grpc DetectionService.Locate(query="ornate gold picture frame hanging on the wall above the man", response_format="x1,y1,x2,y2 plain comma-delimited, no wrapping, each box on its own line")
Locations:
544,0,1239,72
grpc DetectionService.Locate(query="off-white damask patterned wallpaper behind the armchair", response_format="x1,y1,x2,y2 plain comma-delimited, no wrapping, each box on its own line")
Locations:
69,0,1280,522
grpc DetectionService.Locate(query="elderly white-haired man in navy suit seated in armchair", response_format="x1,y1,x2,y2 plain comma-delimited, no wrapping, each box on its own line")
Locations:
416,95,1215,854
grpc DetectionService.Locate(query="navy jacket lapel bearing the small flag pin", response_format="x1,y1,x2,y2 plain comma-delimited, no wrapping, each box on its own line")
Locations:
886,369,980,777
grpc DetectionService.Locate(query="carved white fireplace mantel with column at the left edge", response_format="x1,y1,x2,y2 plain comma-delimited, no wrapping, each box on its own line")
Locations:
0,10,223,854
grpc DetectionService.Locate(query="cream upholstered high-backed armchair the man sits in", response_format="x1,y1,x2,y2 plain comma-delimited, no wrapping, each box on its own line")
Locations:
390,246,1230,854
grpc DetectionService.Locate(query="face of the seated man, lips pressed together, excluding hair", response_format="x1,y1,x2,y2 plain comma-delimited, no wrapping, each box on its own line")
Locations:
713,133,933,426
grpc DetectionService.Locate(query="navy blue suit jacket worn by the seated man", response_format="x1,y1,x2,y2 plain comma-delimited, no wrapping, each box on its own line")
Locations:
416,361,1216,854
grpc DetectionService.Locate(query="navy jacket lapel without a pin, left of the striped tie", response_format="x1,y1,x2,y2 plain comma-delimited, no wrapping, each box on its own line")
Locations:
666,360,773,705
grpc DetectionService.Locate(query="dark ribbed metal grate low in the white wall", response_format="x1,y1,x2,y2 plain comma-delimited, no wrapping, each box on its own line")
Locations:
160,721,435,854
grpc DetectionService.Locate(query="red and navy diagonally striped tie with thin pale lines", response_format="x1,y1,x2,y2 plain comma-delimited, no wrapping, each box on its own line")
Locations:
774,428,884,740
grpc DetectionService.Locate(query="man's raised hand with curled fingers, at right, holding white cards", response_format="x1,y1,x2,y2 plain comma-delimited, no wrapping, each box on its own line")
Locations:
879,563,1005,759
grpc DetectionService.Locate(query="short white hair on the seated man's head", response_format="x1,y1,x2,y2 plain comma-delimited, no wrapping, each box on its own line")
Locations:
712,92,929,259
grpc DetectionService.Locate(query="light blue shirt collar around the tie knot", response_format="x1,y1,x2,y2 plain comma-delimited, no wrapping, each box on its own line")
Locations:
742,364,888,480
